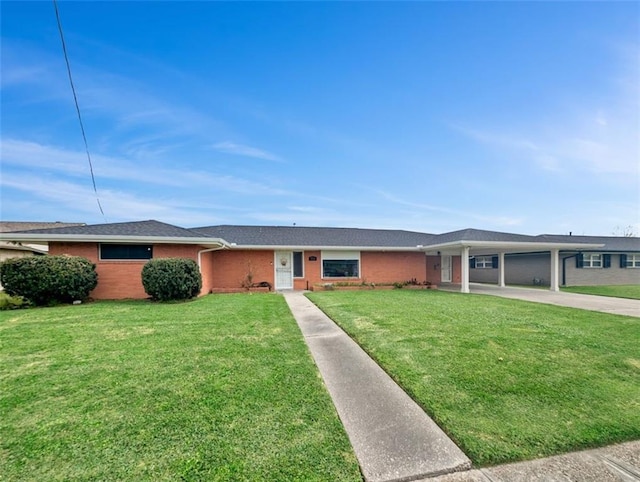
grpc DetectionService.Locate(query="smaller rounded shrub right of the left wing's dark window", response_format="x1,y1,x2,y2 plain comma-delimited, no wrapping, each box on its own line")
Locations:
142,258,202,301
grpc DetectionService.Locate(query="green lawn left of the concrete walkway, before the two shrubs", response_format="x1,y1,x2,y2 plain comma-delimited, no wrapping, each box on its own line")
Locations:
0,294,361,481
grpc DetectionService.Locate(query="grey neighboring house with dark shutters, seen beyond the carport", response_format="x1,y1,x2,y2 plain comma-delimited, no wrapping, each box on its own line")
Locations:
470,234,640,286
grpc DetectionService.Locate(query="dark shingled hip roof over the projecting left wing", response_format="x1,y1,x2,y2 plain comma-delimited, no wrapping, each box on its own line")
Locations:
10,220,203,238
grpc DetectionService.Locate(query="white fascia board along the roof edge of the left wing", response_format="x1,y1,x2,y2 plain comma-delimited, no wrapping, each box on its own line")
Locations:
0,233,229,248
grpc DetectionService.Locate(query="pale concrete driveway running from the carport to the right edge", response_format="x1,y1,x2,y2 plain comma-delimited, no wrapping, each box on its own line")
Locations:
469,283,640,317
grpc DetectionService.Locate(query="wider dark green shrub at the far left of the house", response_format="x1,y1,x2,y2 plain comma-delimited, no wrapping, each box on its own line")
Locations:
0,255,98,305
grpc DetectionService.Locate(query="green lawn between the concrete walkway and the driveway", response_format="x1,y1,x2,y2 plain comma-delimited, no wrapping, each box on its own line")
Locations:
309,290,640,466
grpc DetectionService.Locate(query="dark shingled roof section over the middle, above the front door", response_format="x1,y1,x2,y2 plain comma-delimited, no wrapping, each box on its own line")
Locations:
192,225,433,248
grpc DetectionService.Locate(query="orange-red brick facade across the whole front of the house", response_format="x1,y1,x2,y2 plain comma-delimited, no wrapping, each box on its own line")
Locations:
49,242,468,299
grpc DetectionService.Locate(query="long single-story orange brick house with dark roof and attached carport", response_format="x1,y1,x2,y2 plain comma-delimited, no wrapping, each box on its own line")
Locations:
0,220,640,299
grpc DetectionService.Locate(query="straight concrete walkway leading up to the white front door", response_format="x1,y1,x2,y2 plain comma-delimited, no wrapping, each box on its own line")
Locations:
283,291,471,482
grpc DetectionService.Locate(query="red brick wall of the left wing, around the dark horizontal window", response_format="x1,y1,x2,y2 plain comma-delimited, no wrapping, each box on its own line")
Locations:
49,242,202,300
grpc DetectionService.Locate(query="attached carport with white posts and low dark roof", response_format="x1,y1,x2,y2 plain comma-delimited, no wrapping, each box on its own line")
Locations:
418,229,603,293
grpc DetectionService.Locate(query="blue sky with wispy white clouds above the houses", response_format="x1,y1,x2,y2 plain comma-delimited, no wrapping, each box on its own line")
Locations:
0,1,640,235
